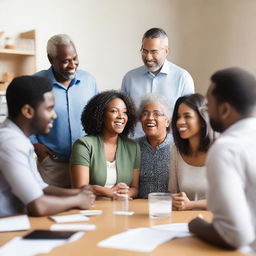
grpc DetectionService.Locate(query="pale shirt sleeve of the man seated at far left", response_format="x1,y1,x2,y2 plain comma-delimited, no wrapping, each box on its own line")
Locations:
0,137,43,205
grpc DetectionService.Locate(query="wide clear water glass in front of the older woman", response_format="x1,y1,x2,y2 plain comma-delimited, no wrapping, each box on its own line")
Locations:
148,193,172,219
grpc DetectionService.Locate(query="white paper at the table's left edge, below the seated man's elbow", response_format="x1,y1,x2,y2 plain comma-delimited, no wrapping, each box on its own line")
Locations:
0,215,30,232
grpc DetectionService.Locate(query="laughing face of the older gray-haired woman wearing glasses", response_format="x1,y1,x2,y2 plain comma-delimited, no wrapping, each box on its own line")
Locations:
140,102,170,139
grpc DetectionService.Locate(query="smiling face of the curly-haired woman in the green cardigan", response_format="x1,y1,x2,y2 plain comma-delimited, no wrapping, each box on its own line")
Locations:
103,98,128,135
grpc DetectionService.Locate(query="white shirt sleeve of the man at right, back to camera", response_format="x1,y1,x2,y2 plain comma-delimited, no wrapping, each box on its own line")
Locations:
207,141,255,248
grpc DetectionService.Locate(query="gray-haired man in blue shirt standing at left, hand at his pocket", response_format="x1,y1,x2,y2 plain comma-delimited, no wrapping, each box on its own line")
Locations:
31,34,98,188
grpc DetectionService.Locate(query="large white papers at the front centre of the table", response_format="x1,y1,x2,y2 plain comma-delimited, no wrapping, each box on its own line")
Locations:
97,223,191,252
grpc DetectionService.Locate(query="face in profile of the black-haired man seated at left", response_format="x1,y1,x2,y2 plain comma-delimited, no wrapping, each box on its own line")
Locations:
31,92,57,134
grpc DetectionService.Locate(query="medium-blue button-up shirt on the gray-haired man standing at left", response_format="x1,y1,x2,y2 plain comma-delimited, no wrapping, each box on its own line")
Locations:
30,68,98,160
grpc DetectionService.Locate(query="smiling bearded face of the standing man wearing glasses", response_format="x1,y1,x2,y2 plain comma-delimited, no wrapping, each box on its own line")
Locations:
141,38,168,74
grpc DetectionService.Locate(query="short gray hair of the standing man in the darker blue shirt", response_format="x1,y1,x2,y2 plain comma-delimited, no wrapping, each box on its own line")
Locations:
47,34,74,58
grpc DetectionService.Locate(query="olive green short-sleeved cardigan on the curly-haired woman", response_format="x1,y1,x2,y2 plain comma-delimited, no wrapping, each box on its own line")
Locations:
70,135,140,186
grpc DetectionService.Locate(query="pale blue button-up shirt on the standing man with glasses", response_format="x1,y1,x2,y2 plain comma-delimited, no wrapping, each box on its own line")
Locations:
121,60,195,138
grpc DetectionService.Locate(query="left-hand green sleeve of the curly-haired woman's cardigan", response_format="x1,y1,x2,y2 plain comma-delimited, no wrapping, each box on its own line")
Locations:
70,138,92,166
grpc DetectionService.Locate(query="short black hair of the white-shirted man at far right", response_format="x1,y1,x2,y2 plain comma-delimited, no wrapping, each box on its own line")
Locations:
211,67,256,115
